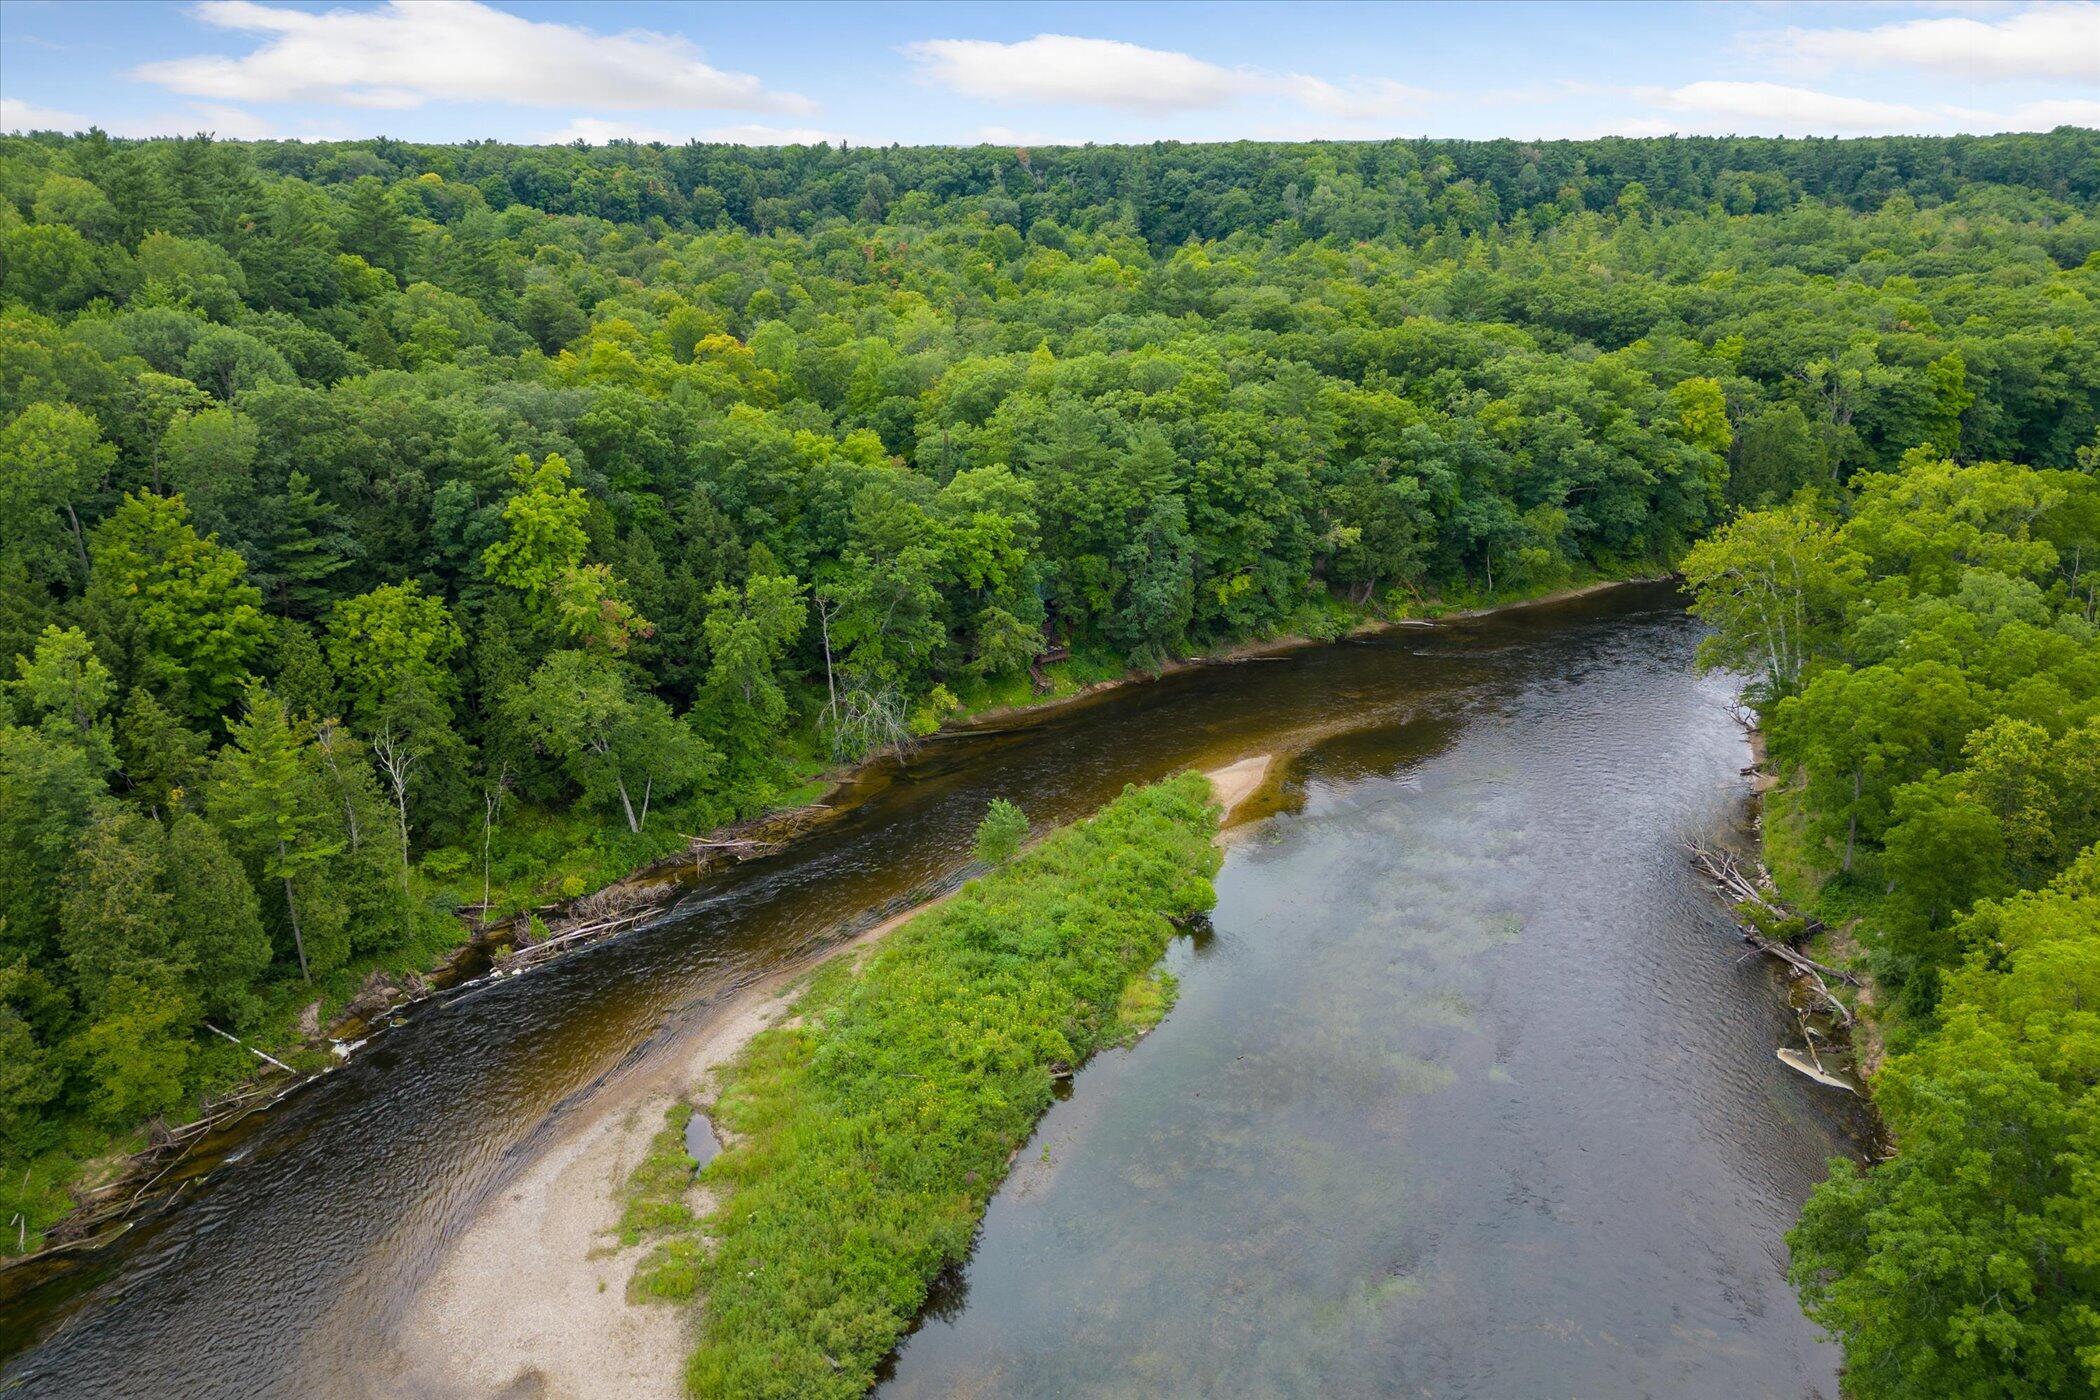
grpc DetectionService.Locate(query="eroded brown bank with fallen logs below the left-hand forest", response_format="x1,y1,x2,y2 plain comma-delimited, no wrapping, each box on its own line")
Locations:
0,573,1621,1274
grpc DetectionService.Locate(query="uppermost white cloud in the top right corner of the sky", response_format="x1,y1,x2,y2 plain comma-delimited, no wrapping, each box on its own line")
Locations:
1777,4,2100,82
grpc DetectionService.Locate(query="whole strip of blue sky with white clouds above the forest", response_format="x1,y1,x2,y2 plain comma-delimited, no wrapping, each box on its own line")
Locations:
0,0,2100,147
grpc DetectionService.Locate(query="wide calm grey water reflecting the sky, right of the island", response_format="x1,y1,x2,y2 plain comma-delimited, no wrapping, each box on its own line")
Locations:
884,596,1873,1398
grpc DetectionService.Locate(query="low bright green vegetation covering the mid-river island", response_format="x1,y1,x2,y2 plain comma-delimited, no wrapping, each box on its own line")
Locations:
645,775,1218,1398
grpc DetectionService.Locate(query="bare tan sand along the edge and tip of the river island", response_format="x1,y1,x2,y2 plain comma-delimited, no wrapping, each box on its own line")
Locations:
380,768,1275,1400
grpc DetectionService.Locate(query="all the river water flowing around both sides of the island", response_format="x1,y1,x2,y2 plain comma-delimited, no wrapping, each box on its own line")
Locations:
0,586,1863,1396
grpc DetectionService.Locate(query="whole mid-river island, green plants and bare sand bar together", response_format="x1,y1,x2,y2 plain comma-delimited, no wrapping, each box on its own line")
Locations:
393,756,1275,1398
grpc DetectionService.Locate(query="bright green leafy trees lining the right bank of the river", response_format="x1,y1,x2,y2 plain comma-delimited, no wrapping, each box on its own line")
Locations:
1684,447,2100,1398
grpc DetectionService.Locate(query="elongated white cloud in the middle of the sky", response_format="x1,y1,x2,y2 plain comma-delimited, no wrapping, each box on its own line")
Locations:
905,34,1260,111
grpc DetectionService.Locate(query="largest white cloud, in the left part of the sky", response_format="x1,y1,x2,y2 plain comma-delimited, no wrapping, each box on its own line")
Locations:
132,0,813,111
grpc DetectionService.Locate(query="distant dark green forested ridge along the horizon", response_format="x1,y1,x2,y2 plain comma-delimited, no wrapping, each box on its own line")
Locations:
32,126,2100,248
